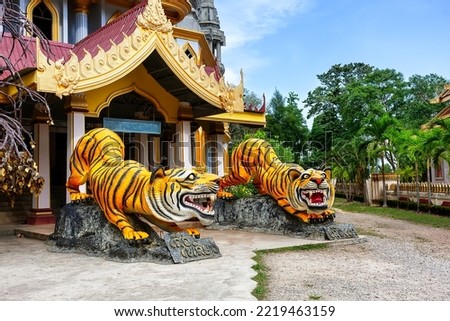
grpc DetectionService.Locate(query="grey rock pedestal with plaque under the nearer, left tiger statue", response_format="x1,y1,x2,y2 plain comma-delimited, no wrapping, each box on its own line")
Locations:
48,204,221,264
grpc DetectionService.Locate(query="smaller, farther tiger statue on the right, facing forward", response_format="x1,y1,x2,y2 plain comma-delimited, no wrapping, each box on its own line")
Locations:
218,138,335,223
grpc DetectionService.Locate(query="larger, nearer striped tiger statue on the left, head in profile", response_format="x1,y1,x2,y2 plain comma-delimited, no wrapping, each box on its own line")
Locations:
66,128,219,240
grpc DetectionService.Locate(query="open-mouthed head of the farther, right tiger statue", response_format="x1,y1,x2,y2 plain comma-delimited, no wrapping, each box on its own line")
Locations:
288,168,334,214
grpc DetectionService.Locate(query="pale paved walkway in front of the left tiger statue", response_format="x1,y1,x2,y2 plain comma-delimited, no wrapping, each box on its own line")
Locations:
0,225,357,301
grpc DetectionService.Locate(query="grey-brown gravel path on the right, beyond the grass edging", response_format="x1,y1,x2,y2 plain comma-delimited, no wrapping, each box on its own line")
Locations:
265,212,450,301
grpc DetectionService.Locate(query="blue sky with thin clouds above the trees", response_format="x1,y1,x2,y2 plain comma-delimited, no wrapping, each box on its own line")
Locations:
215,0,450,122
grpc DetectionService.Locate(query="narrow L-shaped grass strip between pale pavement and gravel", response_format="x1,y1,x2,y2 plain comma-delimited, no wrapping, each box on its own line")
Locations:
252,244,328,300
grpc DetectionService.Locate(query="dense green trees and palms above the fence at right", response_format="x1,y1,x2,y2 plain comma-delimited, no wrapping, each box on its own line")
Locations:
303,63,450,201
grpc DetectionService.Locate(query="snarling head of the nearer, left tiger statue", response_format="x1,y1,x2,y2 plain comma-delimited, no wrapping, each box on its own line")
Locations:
147,168,219,225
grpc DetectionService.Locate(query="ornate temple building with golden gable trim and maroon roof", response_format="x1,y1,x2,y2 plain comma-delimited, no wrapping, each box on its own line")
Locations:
0,0,265,224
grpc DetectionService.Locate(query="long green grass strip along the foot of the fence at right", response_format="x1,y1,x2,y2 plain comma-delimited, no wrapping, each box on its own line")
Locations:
334,198,450,229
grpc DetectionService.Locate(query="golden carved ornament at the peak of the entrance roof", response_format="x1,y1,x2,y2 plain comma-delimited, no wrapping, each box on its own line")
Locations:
136,0,172,32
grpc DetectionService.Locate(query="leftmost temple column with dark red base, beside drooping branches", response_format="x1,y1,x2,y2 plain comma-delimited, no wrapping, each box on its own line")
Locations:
26,107,55,225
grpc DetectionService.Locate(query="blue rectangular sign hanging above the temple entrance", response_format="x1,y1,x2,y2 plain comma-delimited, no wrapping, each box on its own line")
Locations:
103,118,161,135
